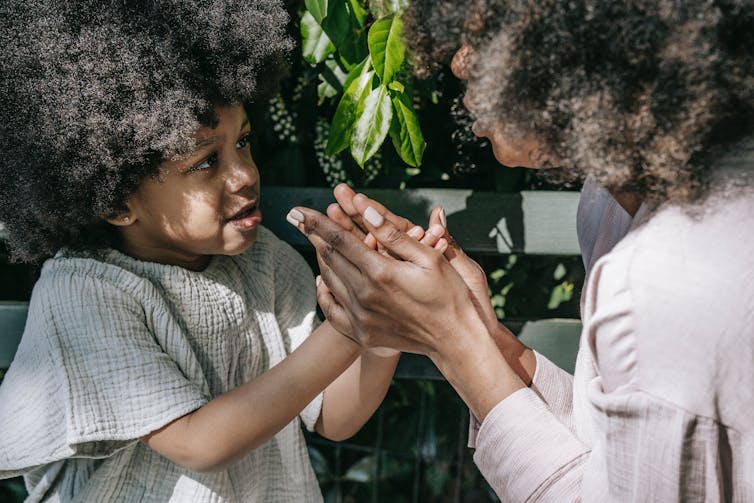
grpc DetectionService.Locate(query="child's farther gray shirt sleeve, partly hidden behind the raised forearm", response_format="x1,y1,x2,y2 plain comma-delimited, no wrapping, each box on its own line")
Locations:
275,238,324,431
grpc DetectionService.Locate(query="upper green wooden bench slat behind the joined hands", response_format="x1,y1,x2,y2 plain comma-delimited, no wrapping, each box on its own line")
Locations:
261,187,579,255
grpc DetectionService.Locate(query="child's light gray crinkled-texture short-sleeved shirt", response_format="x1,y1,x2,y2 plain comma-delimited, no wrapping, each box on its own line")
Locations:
0,228,322,503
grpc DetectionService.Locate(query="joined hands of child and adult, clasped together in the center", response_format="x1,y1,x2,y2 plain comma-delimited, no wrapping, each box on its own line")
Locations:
288,184,499,363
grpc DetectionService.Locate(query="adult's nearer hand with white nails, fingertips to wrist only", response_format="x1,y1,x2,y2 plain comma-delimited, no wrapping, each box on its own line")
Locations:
290,200,486,355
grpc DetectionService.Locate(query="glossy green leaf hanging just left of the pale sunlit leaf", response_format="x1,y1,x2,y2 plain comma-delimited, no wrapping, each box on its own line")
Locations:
325,59,374,156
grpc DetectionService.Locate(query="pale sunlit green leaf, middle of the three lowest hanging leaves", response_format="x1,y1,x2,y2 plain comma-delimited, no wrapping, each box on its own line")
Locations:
351,84,393,168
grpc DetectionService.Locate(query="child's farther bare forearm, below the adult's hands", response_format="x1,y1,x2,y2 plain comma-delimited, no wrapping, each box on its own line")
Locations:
316,323,400,441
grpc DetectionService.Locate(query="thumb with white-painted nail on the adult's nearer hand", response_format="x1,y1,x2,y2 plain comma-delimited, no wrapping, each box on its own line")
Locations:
354,204,439,267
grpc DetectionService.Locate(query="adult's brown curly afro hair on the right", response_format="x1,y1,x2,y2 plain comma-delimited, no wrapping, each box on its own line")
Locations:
406,0,754,203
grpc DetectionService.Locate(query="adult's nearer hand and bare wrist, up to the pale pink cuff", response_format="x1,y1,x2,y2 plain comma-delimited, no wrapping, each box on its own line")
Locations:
288,203,525,420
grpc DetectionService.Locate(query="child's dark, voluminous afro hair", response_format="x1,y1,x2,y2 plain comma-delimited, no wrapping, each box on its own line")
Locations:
0,0,293,262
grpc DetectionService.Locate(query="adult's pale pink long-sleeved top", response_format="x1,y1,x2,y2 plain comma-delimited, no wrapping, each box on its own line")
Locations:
471,144,754,502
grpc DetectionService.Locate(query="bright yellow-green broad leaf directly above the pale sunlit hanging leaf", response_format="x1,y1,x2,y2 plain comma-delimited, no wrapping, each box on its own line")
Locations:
367,17,406,85
